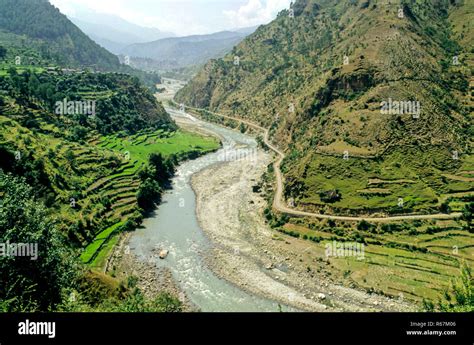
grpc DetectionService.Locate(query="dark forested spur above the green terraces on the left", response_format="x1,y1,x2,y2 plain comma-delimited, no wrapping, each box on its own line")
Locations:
0,67,173,136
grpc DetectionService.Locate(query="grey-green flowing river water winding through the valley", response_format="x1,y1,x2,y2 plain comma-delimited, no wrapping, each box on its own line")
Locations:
130,109,293,312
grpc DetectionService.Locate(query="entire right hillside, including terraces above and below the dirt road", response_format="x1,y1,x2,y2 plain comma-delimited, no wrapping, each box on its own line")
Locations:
175,0,474,303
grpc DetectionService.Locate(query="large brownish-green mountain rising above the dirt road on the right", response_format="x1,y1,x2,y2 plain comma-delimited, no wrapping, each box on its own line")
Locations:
176,0,474,214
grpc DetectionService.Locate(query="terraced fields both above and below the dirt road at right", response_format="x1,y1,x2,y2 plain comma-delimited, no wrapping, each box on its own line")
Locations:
173,100,474,302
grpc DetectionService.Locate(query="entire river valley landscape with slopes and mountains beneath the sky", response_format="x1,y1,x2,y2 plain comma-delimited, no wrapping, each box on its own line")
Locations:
0,0,474,315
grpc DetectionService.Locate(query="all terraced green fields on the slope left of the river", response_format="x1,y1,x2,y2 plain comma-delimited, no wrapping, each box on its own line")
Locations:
0,105,220,269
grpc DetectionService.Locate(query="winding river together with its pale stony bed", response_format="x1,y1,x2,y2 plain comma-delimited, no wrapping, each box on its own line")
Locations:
112,79,414,312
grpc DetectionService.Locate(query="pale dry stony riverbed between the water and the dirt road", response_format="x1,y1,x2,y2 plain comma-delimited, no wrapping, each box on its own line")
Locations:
192,151,414,311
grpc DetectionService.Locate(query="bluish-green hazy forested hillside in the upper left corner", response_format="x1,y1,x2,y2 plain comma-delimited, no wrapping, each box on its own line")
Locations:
0,0,165,90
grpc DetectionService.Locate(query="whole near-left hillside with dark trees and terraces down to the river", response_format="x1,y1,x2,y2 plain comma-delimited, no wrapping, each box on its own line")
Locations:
0,62,219,311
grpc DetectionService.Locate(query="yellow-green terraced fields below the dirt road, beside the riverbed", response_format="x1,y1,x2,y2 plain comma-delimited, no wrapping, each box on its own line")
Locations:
281,219,474,302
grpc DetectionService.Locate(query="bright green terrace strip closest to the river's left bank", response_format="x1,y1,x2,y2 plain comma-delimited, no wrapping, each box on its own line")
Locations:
81,130,219,268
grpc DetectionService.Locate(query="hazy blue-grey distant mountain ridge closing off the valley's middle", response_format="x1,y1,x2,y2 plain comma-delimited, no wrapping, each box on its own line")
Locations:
121,31,247,69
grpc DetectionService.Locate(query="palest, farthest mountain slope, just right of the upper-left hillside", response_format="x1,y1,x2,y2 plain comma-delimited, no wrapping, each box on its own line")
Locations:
70,11,175,54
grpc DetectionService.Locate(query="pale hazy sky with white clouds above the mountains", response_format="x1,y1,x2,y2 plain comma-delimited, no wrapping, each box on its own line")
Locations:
50,0,291,36
